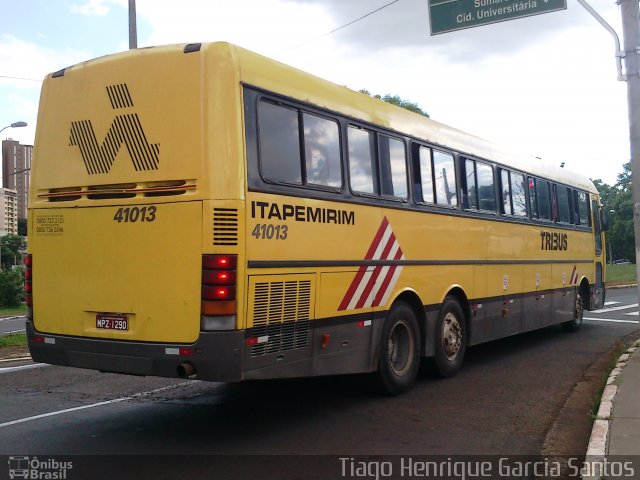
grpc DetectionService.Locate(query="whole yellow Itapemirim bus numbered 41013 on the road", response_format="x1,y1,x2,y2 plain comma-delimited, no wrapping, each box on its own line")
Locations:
26,43,606,394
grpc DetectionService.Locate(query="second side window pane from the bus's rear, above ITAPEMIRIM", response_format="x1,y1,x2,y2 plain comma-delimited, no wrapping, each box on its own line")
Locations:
302,113,342,188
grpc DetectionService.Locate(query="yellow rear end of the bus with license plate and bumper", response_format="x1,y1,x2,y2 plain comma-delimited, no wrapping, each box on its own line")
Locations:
26,45,242,380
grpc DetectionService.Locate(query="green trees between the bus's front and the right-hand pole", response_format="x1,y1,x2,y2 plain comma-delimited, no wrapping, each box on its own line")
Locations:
593,162,636,263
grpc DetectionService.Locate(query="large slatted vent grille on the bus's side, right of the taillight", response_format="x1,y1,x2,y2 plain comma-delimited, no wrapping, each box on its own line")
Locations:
251,280,311,357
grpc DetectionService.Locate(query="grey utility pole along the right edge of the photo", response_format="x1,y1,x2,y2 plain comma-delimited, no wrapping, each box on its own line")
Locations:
620,0,640,306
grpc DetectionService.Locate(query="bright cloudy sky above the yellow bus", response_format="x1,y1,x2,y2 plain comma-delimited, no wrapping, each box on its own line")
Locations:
0,0,630,185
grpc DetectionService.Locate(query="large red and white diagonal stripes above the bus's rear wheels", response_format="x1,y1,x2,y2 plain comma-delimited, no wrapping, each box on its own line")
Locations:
338,217,405,310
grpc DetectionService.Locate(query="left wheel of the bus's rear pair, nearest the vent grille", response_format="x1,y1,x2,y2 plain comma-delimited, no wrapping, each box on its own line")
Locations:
374,302,420,395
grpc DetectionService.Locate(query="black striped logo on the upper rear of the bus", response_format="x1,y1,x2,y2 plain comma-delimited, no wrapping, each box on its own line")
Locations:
69,83,160,175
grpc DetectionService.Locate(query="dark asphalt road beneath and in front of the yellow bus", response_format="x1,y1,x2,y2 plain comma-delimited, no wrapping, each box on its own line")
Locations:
0,289,640,480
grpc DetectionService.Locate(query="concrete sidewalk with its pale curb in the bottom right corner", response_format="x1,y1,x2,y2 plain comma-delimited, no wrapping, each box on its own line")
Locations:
583,340,640,480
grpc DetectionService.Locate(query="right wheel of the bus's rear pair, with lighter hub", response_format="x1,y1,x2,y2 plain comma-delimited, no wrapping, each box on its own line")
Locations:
433,297,467,378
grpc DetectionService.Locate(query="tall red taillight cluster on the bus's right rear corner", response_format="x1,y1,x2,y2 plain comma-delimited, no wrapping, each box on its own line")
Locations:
201,255,238,330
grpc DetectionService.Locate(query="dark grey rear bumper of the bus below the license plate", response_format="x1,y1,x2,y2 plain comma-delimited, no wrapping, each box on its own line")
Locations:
26,320,244,382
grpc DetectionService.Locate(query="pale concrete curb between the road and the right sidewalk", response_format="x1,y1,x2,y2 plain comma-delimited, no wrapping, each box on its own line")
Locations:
582,339,640,480
